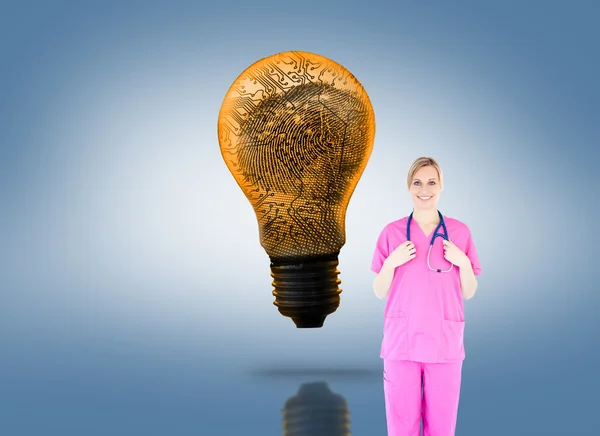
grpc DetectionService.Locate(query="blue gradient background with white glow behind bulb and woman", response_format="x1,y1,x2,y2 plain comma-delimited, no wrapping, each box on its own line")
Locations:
0,1,600,436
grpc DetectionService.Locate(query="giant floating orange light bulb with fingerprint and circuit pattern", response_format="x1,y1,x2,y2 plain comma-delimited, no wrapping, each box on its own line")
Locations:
218,51,375,328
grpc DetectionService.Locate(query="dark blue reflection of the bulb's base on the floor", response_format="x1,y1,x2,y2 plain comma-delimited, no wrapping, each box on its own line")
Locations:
282,381,350,436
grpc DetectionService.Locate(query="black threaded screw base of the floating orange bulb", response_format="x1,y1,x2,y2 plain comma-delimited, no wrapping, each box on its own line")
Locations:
271,254,342,328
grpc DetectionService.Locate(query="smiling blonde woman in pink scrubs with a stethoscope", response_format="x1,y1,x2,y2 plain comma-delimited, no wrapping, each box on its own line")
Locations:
371,157,481,436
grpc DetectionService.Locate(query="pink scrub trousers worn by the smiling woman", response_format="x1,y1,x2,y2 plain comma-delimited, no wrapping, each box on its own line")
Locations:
383,359,462,436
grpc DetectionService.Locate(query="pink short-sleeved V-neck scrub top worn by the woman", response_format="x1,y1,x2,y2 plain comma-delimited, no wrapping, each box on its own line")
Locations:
371,215,481,363
